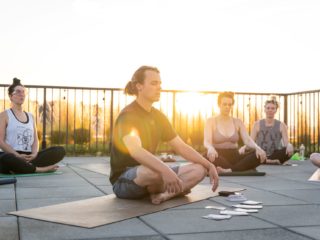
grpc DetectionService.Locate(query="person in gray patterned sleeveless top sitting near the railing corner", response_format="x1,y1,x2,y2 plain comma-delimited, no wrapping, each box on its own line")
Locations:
241,98,293,164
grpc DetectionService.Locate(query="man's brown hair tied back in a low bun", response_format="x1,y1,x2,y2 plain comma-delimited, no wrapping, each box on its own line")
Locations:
124,66,160,96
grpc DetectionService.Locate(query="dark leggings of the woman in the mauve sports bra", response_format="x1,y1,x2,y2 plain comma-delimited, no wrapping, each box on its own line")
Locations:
213,149,261,172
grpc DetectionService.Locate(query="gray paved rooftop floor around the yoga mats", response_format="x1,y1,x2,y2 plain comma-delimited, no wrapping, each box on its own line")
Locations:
0,157,320,240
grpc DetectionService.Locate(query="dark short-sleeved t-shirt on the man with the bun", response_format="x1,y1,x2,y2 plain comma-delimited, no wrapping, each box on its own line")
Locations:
110,101,177,184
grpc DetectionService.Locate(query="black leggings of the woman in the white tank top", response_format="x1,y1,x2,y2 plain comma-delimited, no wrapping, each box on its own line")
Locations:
0,147,66,174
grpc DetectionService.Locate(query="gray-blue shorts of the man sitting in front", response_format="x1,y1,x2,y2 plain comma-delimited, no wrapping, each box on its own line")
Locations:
113,166,179,199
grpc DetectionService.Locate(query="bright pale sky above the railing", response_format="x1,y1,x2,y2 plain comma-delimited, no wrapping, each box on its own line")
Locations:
0,0,320,92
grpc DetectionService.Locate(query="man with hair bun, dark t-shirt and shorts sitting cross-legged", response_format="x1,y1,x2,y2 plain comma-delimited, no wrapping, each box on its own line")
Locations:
110,66,218,204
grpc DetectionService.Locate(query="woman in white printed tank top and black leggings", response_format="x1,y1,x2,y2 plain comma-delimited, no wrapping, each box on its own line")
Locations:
0,78,65,174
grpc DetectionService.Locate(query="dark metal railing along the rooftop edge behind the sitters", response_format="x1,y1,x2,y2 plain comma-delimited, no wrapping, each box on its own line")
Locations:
0,84,320,155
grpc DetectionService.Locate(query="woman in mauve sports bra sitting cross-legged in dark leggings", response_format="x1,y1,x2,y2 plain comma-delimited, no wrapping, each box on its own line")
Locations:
204,92,266,173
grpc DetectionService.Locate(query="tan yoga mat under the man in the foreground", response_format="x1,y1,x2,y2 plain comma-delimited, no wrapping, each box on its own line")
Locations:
8,185,244,228
